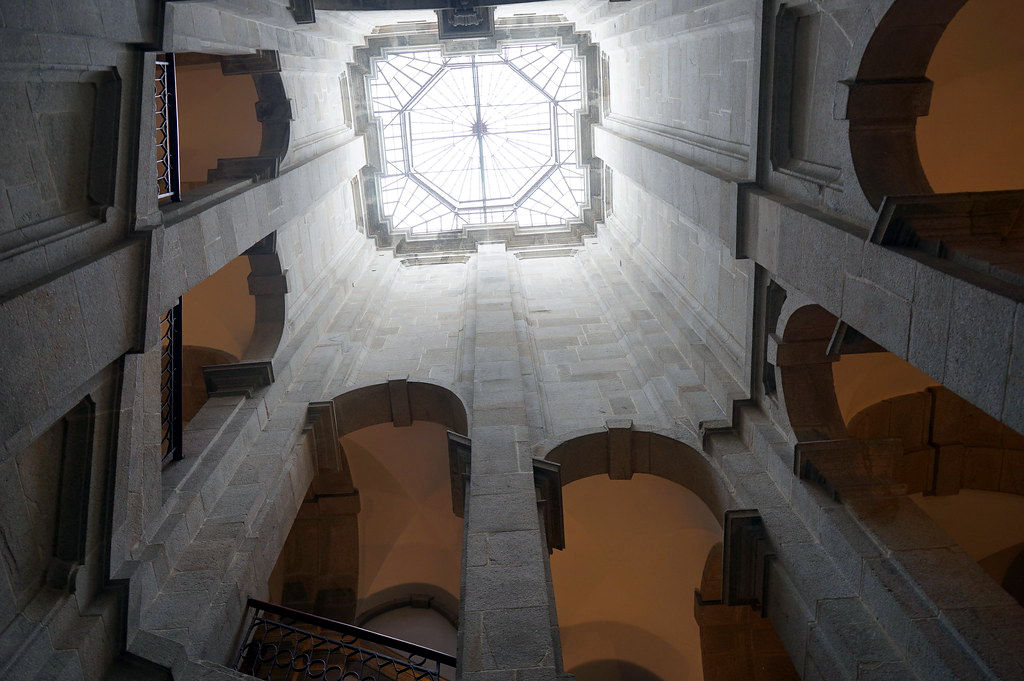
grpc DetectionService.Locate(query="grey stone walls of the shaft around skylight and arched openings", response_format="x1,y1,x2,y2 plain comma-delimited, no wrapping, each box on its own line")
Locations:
0,0,1024,681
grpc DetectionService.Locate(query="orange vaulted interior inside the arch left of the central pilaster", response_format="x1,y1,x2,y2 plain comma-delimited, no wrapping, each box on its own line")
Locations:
271,421,462,622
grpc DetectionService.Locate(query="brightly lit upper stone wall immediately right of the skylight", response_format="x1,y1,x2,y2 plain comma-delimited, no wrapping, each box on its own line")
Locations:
572,0,758,178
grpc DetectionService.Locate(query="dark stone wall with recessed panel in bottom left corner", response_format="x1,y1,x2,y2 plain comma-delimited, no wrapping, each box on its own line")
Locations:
0,366,122,679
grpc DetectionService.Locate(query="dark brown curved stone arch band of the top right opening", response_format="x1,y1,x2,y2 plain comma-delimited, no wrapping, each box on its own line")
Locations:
847,0,967,208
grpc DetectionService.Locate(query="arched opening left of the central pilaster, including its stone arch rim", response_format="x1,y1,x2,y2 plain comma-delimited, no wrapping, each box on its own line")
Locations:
268,380,467,678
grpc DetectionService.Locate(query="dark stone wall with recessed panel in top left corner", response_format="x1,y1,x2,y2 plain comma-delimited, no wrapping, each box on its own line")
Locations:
0,2,157,294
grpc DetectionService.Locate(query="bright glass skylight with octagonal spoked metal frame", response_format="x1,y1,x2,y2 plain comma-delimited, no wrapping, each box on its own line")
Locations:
370,43,588,236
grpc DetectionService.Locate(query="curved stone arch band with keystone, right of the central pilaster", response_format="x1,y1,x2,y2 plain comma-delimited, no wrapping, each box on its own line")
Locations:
545,430,734,524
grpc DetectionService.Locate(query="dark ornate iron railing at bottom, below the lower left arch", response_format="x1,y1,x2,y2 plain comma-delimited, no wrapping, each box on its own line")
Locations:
234,598,456,681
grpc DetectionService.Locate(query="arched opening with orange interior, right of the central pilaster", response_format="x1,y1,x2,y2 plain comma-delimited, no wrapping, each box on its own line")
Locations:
547,428,792,681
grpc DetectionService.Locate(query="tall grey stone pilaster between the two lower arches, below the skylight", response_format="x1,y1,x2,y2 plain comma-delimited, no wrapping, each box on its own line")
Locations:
459,246,557,681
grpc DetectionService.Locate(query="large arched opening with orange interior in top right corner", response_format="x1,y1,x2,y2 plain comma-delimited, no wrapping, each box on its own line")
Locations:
847,0,1024,286
